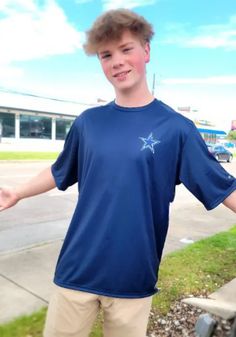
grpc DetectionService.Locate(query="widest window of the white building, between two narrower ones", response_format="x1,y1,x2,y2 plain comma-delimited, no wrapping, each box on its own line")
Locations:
20,115,52,139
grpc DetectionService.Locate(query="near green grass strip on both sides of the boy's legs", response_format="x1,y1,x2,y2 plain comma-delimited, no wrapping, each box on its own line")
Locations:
0,226,236,337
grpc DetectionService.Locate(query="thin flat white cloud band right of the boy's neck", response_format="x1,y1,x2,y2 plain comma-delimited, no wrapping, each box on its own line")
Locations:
161,75,236,85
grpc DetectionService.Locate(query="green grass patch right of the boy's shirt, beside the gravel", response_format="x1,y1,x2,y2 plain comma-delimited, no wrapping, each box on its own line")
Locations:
153,226,236,314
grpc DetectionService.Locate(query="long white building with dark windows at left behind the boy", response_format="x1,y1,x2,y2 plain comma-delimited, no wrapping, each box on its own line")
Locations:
0,94,98,151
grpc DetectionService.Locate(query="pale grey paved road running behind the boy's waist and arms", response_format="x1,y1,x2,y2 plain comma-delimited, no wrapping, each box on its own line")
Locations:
0,161,236,254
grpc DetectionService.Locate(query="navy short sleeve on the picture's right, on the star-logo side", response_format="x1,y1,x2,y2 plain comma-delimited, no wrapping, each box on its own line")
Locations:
179,124,236,210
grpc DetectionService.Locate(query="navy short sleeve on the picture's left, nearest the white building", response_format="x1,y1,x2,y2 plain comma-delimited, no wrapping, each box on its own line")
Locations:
51,118,80,191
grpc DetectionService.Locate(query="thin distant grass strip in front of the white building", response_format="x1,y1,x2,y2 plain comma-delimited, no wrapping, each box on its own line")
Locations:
0,151,59,160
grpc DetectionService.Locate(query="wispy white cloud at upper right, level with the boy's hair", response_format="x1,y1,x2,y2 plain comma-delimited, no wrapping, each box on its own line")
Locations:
163,15,236,50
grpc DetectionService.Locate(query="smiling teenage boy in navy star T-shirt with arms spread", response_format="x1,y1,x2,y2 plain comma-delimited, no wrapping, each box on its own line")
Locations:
0,9,236,337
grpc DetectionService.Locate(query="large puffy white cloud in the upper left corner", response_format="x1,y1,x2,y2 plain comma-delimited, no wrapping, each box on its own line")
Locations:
0,0,83,65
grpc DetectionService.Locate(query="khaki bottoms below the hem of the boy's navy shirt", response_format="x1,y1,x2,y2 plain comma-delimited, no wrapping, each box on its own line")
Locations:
44,286,152,337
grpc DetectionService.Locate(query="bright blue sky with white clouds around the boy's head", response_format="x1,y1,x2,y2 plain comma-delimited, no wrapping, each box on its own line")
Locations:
0,0,236,128
